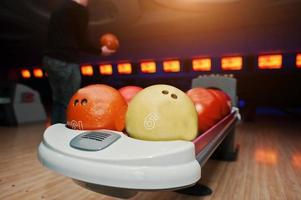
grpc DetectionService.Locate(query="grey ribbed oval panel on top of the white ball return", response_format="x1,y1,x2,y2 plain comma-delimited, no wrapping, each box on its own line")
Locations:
70,131,121,151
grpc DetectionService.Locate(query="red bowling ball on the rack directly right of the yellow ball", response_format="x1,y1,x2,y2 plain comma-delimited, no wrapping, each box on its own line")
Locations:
187,87,221,132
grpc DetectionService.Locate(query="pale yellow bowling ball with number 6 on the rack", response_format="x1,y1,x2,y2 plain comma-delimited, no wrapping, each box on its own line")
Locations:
126,85,198,141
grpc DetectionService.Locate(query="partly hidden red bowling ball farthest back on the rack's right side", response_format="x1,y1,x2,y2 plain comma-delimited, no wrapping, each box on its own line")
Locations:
208,89,231,118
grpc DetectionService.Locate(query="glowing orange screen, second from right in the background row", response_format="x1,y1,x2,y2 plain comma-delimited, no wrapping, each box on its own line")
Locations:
258,54,282,69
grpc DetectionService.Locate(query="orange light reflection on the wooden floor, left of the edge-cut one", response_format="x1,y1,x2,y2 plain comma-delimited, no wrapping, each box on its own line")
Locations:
255,149,278,165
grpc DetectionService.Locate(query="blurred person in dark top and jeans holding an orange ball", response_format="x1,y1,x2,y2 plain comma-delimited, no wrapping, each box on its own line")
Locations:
43,0,115,124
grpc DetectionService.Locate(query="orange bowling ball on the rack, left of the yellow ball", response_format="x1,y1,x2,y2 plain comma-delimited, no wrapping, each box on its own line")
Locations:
67,84,127,131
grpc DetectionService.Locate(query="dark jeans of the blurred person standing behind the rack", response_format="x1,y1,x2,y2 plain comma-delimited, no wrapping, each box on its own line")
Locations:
43,56,81,124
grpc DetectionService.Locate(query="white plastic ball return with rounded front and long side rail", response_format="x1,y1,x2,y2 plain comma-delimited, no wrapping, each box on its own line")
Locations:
38,77,239,198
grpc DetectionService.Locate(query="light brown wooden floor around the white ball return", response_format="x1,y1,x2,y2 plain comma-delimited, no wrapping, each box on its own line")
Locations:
0,117,301,200
